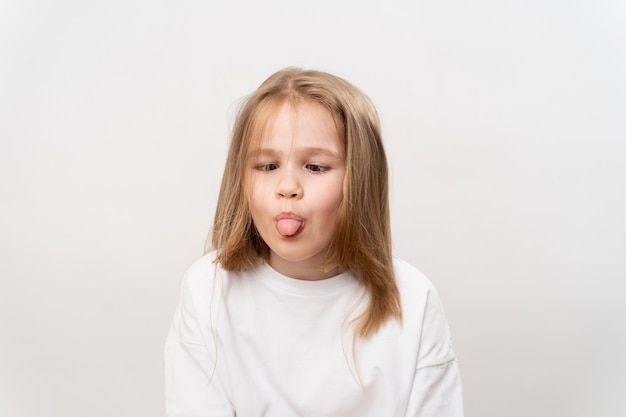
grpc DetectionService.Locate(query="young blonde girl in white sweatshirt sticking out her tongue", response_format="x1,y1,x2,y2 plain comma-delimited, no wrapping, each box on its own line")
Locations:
165,68,463,417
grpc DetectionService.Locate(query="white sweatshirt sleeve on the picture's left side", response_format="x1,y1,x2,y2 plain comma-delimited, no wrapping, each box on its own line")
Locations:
164,266,235,417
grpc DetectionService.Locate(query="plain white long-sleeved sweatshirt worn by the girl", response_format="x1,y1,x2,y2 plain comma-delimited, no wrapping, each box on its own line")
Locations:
165,253,463,417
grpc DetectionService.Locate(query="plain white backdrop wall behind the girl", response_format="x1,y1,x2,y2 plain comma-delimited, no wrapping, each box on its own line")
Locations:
0,0,626,417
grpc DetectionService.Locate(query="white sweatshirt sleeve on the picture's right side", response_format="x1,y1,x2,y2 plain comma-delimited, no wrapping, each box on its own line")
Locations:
406,288,463,417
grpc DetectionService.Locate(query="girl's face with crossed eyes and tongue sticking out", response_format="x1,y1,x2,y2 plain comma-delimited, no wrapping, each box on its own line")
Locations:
245,101,345,279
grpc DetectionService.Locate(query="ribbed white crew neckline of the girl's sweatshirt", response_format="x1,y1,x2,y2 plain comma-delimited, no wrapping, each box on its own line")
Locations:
258,261,358,297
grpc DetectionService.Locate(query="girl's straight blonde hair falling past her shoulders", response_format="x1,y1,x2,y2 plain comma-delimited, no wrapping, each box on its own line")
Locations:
207,68,402,337
